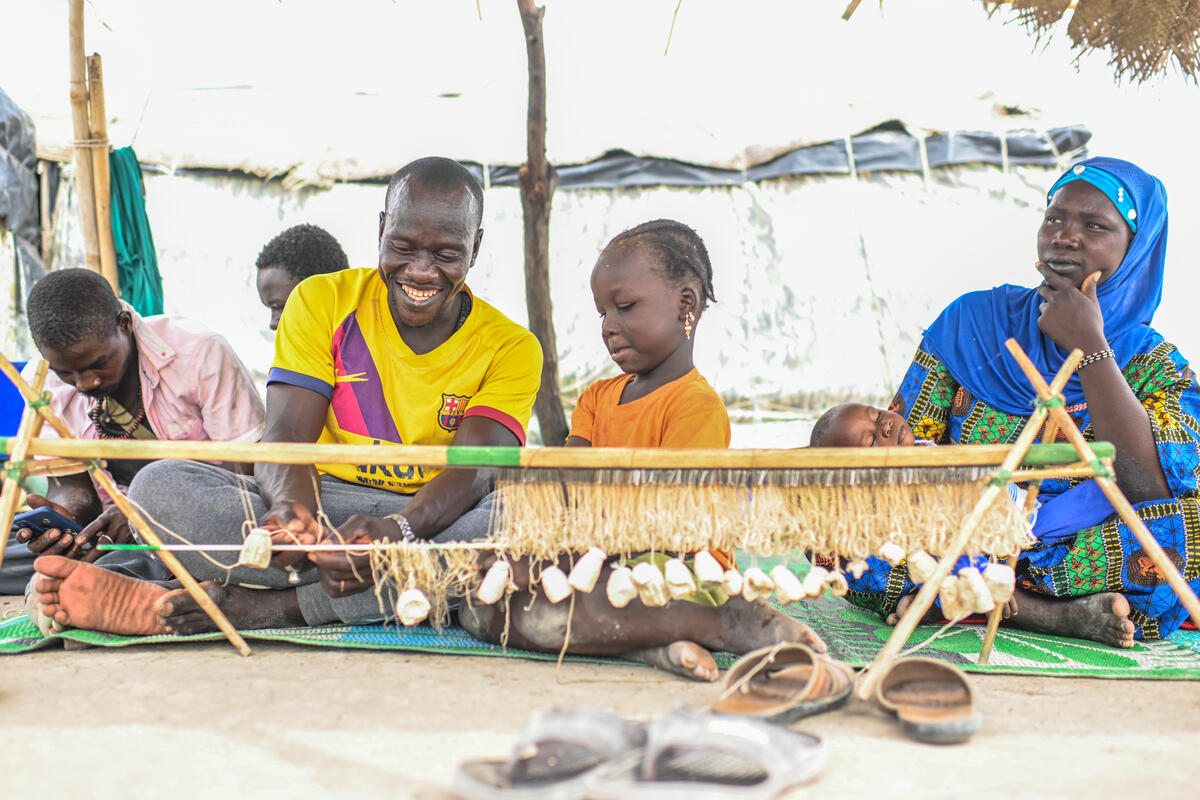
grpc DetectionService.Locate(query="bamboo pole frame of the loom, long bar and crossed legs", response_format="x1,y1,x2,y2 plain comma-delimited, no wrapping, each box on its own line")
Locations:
0,339,1200,681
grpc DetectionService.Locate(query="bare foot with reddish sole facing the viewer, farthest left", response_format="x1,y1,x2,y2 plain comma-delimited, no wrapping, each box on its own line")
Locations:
34,555,168,636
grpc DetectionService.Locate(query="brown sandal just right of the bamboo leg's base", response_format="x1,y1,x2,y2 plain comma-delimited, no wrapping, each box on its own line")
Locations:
875,656,982,745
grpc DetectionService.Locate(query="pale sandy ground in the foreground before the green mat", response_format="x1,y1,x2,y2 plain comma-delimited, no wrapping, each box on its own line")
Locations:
0,601,1200,800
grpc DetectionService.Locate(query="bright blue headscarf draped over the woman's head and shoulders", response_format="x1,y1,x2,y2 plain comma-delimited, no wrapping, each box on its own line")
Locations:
925,157,1166,543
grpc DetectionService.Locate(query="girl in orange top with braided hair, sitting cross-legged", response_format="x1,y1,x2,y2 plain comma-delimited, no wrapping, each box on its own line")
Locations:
460,219,826,680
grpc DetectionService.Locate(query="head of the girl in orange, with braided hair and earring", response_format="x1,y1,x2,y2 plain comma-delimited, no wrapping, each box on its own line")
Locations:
592,219,716,374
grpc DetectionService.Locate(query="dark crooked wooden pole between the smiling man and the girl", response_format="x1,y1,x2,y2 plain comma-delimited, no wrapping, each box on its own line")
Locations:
517,0,570,446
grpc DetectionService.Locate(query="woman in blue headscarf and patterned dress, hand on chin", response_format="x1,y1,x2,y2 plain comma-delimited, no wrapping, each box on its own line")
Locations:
851,157,1200,648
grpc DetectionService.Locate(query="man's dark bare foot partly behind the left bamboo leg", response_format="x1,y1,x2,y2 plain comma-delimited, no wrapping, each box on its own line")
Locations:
154,581,305,636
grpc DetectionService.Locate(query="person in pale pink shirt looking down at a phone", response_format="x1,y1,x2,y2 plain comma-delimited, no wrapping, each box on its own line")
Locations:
0,270,265,594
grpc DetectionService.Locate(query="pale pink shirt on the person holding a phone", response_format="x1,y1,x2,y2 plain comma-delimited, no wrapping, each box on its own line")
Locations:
25,302,266,503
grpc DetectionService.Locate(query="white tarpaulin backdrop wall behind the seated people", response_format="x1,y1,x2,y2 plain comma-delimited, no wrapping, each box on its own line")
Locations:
0,0,1200,443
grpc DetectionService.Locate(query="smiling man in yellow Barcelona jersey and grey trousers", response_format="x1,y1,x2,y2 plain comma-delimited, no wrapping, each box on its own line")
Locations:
35,158,541,633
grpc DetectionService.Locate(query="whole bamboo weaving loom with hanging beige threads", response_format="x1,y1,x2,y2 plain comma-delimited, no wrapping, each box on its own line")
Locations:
0,341,1200,698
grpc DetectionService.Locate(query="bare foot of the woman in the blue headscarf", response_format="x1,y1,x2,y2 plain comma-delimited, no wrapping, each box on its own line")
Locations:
1010,589,1134,649
